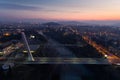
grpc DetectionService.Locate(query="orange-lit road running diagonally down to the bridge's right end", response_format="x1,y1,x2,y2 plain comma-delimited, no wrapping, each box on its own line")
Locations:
82,36,120,64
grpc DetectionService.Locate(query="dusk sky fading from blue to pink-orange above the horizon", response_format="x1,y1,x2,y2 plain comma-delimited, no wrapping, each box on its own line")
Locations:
0,0,120,21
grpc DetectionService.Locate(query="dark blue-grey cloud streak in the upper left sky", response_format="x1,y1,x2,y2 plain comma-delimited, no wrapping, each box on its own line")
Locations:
0,3,43,10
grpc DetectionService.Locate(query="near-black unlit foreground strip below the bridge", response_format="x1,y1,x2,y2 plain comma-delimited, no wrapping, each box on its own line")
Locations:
0,64,120,80
